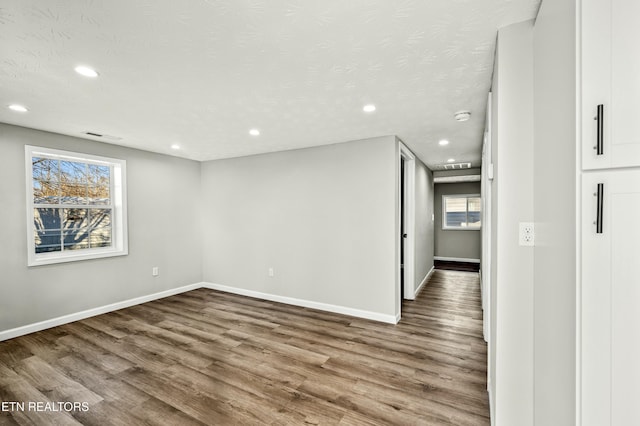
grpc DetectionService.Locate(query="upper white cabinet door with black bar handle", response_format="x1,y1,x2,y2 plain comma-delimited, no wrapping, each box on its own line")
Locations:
581,0,640,169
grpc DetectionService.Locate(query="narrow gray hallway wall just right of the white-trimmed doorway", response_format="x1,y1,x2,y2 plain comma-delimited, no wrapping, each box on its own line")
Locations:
414,158,434,289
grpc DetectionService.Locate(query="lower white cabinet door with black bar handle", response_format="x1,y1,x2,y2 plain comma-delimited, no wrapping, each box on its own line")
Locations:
581,169,640,426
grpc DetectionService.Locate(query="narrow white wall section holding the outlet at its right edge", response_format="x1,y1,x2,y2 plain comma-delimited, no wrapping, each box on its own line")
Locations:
489,21,534,426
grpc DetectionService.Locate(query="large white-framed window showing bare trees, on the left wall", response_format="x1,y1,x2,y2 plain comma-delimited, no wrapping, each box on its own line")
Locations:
25,145,128,266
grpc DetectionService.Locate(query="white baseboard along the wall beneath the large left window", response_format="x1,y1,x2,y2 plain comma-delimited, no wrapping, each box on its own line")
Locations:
0,283,204,342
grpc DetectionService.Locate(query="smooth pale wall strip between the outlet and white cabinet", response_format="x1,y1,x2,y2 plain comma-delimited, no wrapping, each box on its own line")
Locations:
534,0,579,426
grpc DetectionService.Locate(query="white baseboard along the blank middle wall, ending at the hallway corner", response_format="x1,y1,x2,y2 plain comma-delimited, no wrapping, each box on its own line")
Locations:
202,283,399,324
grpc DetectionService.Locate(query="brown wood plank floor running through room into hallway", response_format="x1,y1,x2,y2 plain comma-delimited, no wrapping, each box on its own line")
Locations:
0,270,489,426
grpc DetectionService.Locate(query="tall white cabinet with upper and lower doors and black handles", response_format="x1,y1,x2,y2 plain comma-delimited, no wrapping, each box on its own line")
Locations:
578,0,640,426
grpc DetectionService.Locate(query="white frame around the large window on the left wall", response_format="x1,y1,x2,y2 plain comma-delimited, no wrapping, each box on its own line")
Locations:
25,145,129,266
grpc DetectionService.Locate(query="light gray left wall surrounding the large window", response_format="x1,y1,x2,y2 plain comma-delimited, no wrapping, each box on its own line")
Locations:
0,124,202,330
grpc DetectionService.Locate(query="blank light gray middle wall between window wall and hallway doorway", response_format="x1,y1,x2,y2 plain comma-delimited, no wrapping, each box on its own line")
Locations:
202,136,399,316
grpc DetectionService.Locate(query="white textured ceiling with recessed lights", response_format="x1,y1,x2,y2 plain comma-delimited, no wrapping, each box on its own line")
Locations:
0,0,539,168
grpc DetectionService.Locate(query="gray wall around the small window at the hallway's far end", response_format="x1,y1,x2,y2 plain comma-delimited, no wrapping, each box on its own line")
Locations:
434,182,482,259
